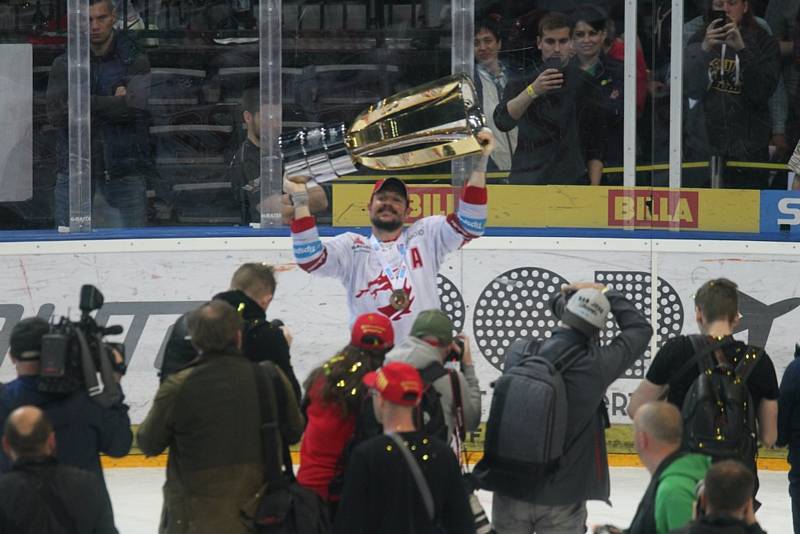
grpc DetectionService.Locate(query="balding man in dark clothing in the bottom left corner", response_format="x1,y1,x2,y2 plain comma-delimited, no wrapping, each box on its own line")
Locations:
0,406,117,534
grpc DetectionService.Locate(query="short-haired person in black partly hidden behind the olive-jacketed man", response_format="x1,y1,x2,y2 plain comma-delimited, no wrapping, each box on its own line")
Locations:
160,263,301,402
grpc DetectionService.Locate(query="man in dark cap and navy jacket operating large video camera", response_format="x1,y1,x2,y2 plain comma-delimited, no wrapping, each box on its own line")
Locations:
0,317,133,496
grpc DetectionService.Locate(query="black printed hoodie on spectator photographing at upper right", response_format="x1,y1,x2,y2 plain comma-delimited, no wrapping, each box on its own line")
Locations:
684,23,781,158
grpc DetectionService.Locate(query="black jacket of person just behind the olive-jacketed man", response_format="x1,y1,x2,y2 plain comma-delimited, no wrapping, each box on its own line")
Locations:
214,289,302,403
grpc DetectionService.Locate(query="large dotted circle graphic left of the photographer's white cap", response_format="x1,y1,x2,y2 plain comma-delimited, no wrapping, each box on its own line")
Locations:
472,267,569,370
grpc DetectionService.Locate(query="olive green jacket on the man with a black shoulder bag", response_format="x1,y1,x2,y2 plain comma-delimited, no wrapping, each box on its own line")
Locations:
136,353,303,534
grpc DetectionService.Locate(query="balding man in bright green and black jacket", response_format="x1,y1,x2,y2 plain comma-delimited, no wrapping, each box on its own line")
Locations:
595,401,711,534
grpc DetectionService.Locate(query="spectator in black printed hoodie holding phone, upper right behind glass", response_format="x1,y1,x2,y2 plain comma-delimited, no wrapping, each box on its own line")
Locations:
684,0,780,189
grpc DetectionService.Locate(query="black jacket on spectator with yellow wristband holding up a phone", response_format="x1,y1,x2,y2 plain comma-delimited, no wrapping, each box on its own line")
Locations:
494,59,606,185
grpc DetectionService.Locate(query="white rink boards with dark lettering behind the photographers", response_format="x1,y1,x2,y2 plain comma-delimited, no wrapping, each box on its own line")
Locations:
0,237,800,423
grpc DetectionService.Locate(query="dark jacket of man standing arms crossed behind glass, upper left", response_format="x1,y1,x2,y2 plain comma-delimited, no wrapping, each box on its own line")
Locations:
47,31,154,179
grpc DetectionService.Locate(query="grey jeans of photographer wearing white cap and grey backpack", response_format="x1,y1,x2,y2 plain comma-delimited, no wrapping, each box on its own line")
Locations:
492,493,586,534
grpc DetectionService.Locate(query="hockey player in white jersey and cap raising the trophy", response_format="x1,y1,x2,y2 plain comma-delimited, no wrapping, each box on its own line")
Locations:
284,129,494,342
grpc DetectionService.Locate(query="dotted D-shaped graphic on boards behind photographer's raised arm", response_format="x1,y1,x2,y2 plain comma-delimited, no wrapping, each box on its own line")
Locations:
595,271,683,379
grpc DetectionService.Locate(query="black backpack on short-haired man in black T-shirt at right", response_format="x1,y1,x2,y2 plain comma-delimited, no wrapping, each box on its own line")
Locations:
676,335,764,465
